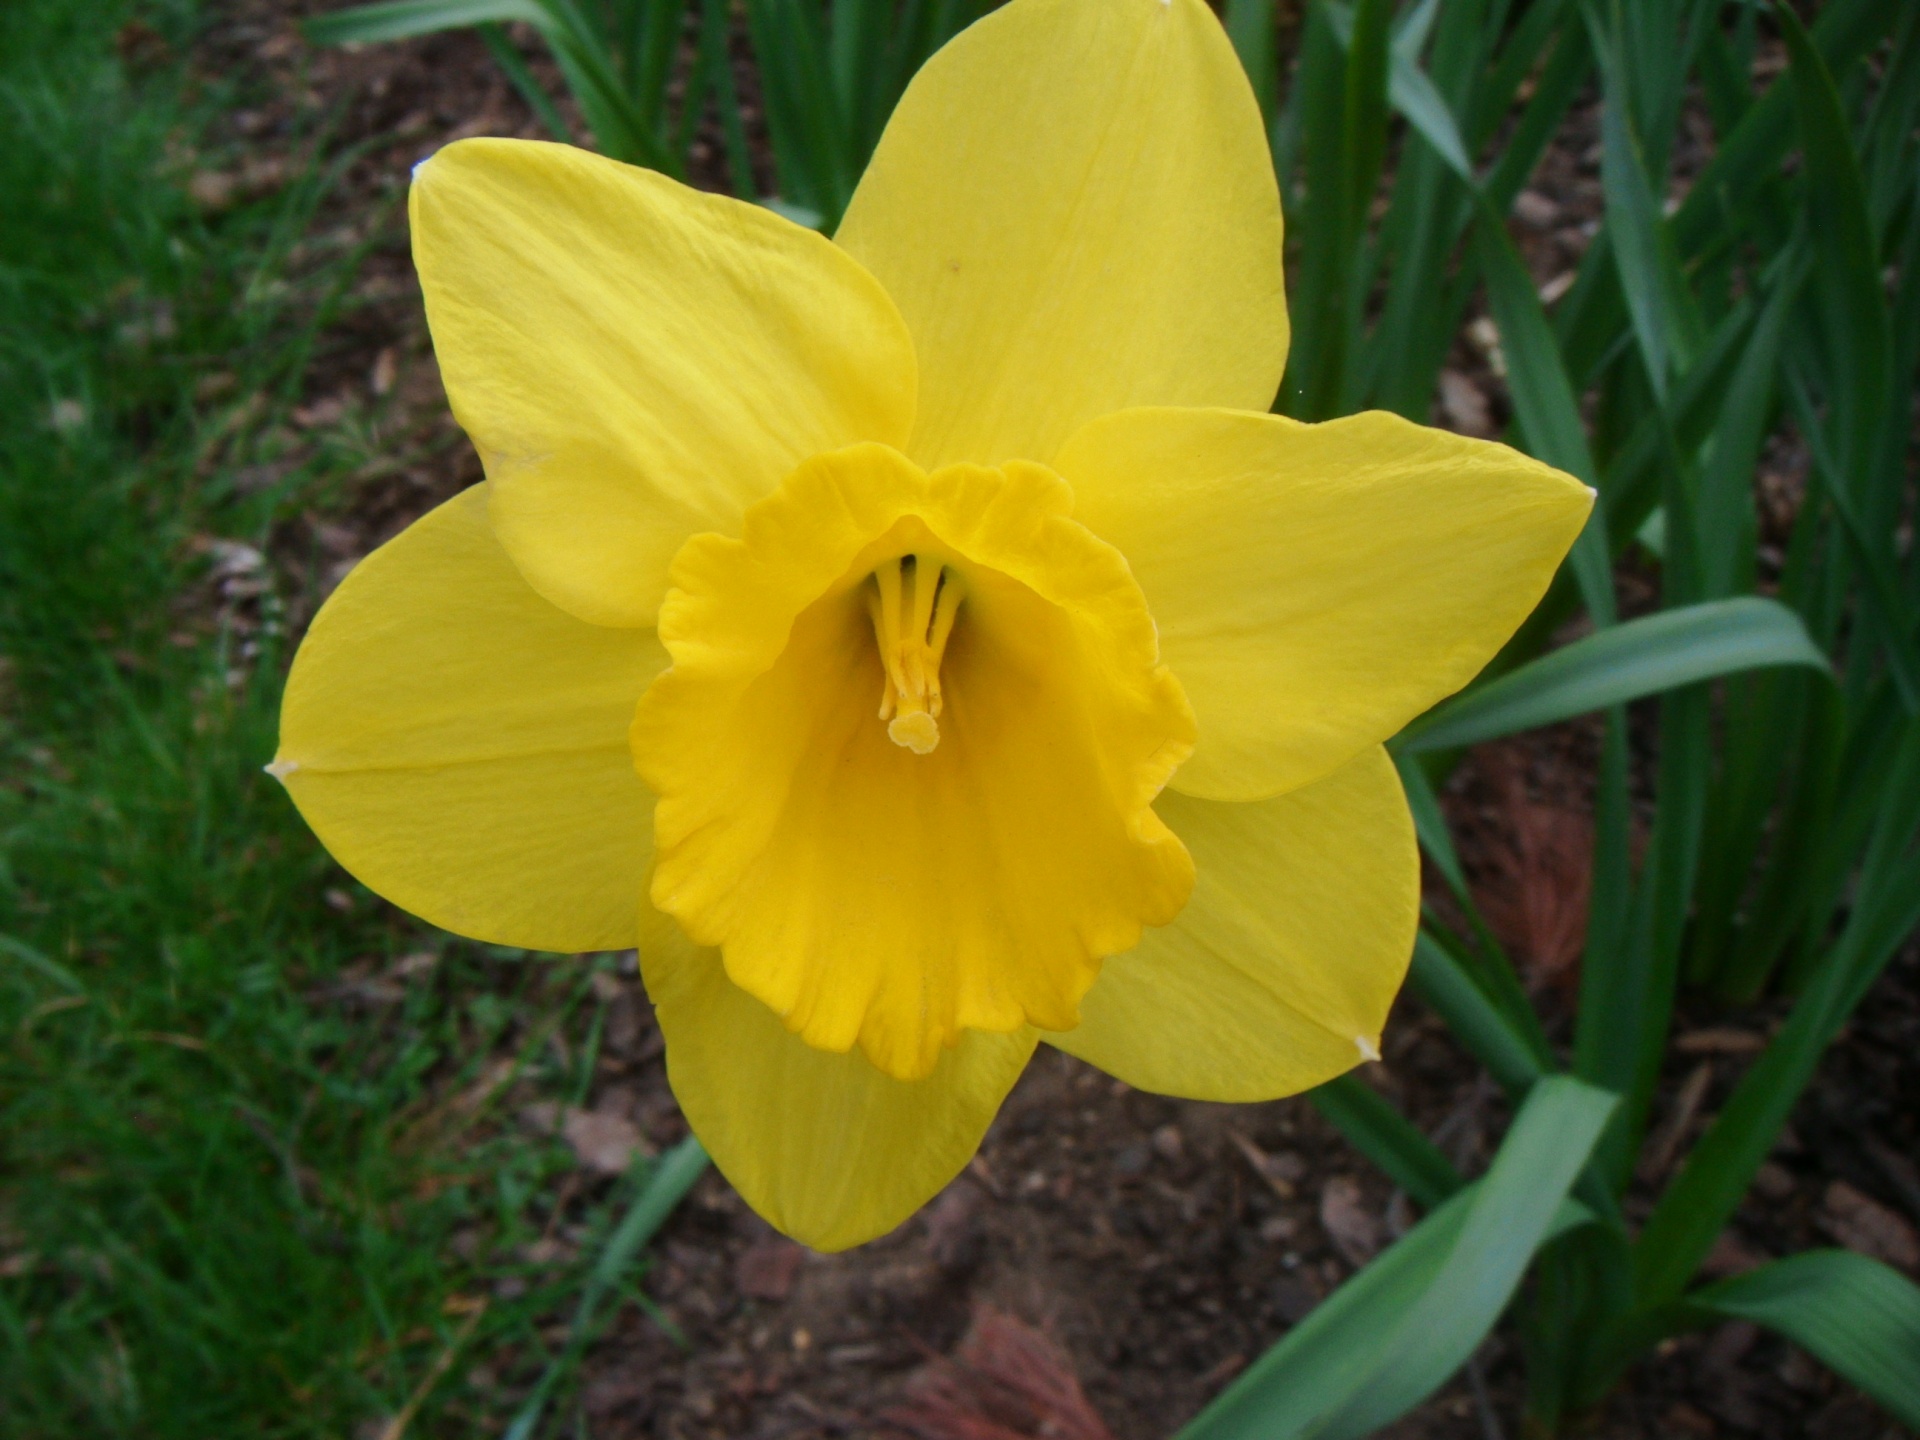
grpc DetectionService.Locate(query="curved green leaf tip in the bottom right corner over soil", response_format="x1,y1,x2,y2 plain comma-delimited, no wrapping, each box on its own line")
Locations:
1688,1250,1920,1427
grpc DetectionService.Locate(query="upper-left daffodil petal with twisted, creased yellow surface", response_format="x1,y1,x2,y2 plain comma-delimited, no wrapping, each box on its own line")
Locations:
411,140,914,626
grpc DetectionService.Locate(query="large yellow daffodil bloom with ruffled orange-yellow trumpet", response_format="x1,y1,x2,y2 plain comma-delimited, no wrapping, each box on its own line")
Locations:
273,0,1590,1248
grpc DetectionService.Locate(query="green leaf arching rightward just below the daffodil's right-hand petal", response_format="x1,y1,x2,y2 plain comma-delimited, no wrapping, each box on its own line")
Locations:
1394,595,1828,755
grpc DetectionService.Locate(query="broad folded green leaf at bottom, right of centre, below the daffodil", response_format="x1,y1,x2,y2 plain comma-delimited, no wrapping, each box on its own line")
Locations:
1179,1075,1615,1440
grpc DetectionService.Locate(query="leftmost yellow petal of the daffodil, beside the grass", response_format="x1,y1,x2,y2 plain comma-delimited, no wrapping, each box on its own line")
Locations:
273,486,666,950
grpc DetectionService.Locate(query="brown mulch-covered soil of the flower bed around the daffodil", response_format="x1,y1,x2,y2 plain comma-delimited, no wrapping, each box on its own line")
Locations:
182,0,1920,1440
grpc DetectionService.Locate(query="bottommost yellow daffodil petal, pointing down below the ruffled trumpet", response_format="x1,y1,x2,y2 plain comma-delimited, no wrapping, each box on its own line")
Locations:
639,906,1035,1250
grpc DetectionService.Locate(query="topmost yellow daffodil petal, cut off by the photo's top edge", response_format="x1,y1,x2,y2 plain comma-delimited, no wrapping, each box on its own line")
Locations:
835,0,1286,468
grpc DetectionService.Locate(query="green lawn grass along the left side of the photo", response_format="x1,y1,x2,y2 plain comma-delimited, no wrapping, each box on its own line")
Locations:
0,0,664,1440
